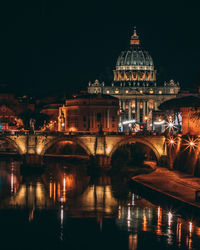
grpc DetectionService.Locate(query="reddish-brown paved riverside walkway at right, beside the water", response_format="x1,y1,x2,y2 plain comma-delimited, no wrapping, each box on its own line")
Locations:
132,167,200,208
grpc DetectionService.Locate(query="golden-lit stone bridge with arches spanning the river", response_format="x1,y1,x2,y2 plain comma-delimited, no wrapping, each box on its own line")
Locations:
0,132,167,165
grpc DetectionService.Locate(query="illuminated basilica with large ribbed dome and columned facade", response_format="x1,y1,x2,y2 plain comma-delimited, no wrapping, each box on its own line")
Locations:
88,29,180,131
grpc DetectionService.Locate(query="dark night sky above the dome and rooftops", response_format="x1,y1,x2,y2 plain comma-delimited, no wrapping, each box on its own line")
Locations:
0,0,200,93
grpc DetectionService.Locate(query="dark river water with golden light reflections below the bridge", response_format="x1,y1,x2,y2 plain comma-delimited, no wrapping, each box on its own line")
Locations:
0,157,200,250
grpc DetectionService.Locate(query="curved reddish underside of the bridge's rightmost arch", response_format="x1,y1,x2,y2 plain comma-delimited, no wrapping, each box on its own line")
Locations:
108,137,161,162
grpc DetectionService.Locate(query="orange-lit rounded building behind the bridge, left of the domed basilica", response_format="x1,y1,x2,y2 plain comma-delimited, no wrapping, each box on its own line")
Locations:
58,94,119,132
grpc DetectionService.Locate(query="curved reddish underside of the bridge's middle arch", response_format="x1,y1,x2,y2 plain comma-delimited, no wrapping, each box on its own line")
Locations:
40,137,92,155
